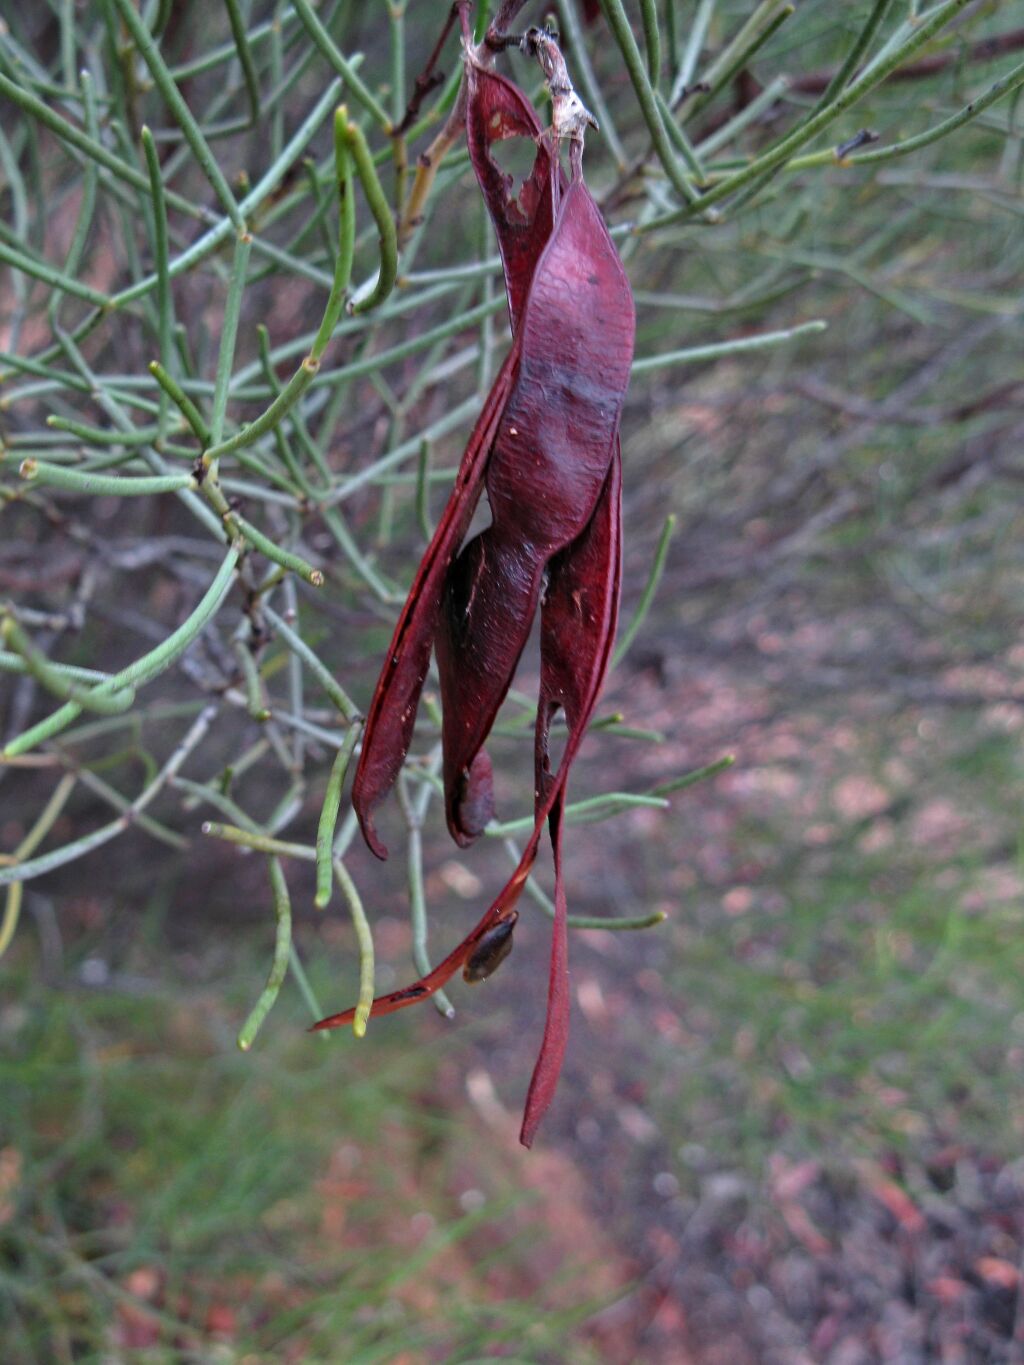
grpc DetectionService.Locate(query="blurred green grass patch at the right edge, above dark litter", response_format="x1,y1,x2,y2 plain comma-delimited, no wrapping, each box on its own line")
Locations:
636,714,1024,1181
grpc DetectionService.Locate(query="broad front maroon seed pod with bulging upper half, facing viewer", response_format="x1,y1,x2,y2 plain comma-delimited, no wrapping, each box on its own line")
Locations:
436,180,634,844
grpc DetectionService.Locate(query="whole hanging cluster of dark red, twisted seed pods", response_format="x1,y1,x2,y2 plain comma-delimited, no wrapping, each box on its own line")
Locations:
315,25,635,1147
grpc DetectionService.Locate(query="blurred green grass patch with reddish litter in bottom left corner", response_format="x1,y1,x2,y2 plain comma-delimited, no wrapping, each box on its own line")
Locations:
0,917,618,1365
